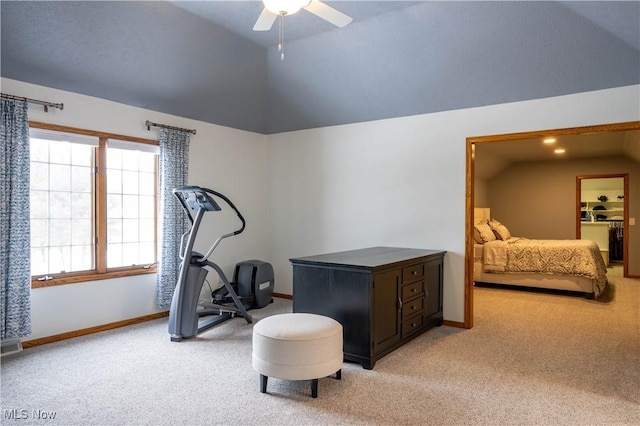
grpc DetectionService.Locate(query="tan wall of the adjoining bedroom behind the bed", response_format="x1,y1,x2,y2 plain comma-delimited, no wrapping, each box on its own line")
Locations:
487,157,640,276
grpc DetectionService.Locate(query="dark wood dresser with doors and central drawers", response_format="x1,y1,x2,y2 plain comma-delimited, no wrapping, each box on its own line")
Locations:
290,247,446,369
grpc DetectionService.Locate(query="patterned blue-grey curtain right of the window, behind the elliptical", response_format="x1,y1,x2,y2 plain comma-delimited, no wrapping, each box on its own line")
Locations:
156,128,190,308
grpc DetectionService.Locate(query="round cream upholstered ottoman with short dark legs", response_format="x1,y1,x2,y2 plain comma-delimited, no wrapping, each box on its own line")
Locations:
252,313,343,398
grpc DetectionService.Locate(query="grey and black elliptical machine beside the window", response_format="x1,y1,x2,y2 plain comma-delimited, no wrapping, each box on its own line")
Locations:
169,186,274,342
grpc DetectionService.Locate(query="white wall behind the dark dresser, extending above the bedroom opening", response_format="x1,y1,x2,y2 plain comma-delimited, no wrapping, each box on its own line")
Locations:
268,86,640,322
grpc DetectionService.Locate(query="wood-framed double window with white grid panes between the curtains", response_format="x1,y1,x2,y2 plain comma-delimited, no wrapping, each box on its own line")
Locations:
31,123,158,287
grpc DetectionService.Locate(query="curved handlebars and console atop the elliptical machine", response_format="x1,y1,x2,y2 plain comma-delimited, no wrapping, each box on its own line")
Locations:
172,185,246,262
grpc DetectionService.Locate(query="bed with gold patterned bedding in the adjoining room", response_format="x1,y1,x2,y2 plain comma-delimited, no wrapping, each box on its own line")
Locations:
473,209,607,298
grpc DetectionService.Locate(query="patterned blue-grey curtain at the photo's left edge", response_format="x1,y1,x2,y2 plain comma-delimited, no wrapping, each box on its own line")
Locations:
0,99,31,340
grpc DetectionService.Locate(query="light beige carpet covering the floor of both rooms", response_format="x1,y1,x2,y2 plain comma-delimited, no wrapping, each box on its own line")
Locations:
1,272,640,425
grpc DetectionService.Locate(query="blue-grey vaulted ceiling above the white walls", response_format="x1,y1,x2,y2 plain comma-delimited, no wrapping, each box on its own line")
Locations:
0,0,640,134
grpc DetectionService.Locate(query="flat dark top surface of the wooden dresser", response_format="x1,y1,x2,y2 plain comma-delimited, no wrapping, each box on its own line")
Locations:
289,247,446,268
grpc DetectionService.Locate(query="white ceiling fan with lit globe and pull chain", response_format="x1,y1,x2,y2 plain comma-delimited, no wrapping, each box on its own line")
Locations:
253,0,353,60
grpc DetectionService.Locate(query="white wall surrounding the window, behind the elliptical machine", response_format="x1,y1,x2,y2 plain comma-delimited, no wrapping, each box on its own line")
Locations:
2,78,267,340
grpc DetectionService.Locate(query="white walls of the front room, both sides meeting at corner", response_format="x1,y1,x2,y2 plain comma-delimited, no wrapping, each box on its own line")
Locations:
2,79,640,338
